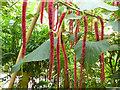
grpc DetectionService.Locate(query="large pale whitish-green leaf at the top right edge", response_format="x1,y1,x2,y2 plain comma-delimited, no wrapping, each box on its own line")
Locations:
73,0,119,11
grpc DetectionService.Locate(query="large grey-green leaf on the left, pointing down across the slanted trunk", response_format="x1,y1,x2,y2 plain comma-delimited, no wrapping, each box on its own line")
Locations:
11,38,57,73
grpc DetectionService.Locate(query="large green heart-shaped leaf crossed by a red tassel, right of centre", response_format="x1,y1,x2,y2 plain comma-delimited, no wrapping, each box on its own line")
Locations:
74,40,110,66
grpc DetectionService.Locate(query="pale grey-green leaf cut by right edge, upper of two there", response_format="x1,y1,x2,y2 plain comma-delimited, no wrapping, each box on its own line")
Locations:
106,20,120,32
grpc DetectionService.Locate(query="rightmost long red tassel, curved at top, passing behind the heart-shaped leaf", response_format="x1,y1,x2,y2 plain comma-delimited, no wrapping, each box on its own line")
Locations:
98,16,105,83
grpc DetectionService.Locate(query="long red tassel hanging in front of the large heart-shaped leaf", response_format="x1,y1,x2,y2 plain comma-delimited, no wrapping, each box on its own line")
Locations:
79,16,88,88
